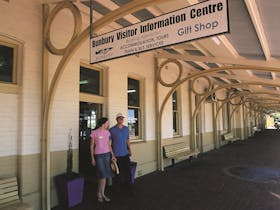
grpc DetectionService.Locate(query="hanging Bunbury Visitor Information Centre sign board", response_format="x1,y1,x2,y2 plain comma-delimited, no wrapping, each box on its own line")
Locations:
90,0,229,64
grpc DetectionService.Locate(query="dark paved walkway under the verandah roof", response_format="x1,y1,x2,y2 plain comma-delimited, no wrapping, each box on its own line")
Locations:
54,130,280,210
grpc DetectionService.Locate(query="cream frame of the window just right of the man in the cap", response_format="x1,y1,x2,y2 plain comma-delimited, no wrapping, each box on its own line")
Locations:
127,74,145,142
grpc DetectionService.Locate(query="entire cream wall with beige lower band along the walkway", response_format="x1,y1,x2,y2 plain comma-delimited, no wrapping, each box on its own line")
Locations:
0,0,250,209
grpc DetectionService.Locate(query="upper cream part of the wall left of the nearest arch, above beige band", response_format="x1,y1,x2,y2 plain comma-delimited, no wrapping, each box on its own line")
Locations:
0,0,41,156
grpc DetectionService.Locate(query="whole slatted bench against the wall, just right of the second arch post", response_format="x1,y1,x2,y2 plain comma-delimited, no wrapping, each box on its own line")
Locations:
163,142,194,166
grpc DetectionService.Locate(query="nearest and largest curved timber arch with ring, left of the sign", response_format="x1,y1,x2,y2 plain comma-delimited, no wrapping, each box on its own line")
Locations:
41,0,173,210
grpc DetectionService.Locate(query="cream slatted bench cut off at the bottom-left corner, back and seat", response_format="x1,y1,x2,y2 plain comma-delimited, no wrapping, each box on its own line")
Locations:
0,177,33,210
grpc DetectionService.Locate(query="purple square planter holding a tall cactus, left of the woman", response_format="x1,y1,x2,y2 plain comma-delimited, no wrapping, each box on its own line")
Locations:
55,173,84,208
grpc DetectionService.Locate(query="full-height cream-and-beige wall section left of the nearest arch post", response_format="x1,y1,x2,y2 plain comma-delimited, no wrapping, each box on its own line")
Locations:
0,0,42,209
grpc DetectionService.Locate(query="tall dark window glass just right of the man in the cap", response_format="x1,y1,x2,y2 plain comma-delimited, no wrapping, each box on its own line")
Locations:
127,78,141,139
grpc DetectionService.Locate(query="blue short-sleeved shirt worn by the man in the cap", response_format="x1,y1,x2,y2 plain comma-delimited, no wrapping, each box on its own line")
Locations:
110,125,129,157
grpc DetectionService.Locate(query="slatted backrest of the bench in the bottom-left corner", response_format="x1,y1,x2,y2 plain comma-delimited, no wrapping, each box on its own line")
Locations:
0,177,20,207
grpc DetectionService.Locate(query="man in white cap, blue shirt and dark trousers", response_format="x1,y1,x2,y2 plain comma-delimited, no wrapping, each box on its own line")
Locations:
110,113,132,194
